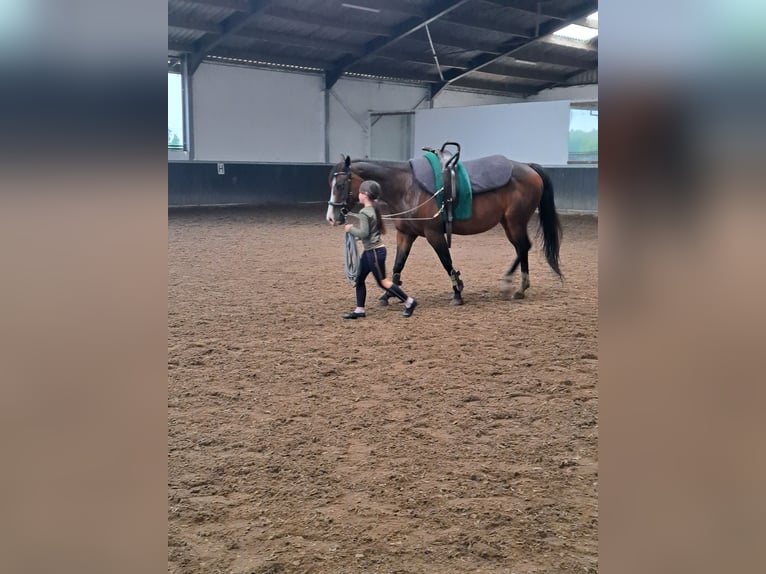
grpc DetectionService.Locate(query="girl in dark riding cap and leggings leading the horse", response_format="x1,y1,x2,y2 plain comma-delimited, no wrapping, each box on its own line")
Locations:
343,179,418,319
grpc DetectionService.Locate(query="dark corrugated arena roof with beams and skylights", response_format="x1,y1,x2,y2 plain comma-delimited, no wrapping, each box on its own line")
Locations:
168,0,598,95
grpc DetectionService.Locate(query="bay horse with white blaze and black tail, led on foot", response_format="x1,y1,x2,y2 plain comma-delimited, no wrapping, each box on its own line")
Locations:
326,156,562,305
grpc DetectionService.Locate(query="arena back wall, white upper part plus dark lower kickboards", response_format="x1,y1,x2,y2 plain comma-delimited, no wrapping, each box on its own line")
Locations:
168,63,598,212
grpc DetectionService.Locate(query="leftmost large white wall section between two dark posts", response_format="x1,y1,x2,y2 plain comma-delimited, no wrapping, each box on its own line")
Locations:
192,64,324,163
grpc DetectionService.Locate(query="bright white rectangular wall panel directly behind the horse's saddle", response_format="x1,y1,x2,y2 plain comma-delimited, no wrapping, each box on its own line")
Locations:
415,101,569,165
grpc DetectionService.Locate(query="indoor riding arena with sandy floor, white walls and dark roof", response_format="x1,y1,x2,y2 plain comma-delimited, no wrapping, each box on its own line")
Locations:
168,0,598,574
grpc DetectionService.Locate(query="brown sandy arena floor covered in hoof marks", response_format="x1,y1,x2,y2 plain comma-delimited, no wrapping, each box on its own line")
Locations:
168,205,598,574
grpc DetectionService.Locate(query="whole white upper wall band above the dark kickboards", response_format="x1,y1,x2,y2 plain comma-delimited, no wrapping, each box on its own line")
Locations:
178,63,598,165
